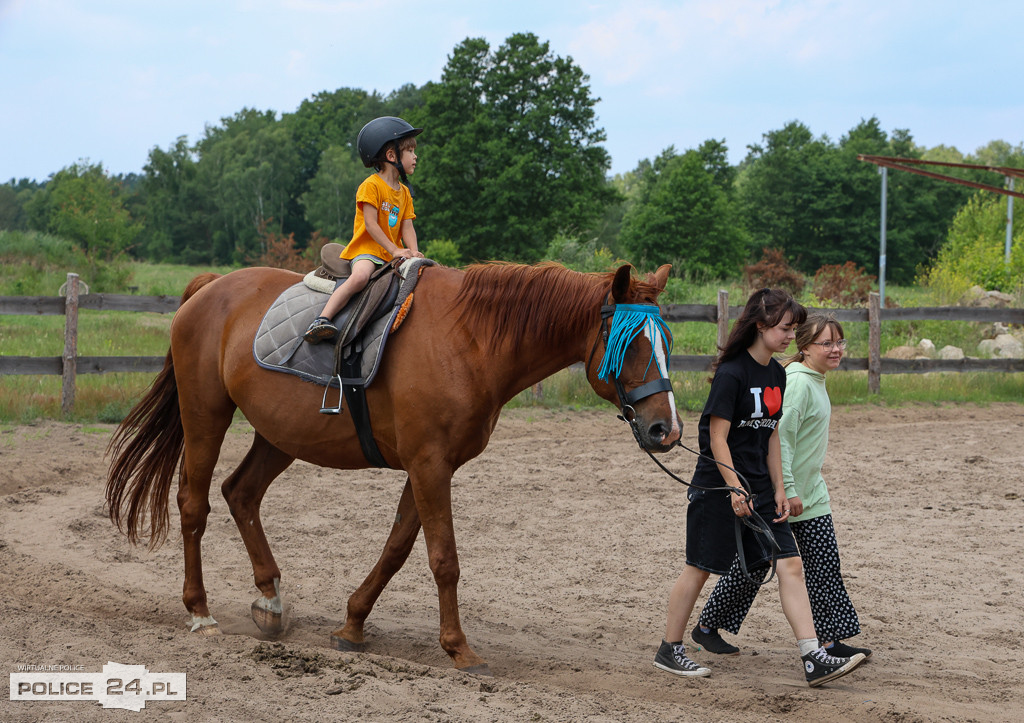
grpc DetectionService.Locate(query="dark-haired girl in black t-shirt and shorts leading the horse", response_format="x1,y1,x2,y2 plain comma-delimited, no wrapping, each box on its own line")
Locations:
654,289,864,686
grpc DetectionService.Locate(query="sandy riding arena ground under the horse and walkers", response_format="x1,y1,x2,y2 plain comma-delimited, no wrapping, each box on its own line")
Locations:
0,405,1024,722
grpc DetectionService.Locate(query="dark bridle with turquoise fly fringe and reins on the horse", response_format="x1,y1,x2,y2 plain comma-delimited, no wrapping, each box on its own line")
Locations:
587,292,781,587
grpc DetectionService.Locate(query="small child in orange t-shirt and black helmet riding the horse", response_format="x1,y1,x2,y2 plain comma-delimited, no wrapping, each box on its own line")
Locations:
302,116,423,344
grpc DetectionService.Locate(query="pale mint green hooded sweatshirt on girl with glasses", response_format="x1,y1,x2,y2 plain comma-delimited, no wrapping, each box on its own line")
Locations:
778,362,831,522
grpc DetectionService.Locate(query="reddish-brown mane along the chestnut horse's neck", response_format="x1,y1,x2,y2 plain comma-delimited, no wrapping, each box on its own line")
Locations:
454,261,657,348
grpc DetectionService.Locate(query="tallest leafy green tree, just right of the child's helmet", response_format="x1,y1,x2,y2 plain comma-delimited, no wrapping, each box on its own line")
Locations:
410,33,615,261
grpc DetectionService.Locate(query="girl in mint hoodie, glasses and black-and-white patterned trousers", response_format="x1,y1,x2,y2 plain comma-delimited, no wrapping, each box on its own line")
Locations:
691,313,871,657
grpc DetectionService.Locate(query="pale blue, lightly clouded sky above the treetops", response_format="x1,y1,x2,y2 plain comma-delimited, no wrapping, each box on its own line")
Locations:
0,0,1024,182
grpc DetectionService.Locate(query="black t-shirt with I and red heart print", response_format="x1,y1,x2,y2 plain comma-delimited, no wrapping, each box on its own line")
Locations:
693,351,785,494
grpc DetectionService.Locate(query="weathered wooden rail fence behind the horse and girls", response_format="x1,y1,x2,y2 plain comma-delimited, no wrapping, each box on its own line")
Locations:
0,273,1024,414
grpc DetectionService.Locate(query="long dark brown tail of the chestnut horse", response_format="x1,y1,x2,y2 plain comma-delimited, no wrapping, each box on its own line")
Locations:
106,273,219,550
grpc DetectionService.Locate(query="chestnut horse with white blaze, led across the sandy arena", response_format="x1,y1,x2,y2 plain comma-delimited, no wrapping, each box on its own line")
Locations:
106,263,681,673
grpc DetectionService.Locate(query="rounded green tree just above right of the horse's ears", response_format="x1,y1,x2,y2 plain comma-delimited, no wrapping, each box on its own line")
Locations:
620,147,748,278
